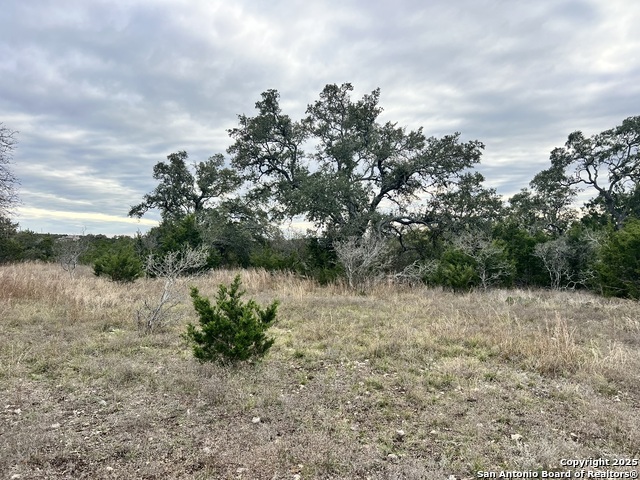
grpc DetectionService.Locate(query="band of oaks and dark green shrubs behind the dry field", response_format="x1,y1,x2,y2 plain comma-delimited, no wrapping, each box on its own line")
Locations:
0,83,640,298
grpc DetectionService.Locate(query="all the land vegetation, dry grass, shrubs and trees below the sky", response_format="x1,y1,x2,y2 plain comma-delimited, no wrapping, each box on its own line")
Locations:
0,89,640,479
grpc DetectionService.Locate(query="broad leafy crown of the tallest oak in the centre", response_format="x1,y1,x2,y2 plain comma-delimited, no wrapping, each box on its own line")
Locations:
228,83,484,238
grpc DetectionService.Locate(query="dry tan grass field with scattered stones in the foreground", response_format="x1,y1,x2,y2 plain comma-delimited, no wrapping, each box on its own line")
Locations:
0,264,640,479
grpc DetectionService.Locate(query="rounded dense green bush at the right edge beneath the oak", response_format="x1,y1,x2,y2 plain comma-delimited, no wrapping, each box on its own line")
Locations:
596,219,640,299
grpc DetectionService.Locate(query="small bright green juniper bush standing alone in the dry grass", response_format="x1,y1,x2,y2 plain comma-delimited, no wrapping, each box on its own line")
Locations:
184,275,278,364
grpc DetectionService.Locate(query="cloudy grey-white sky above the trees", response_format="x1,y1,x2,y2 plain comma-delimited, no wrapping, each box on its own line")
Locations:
0,0,640,235
